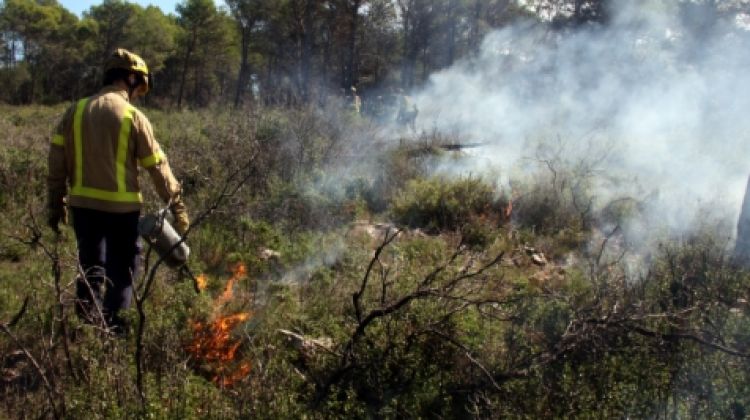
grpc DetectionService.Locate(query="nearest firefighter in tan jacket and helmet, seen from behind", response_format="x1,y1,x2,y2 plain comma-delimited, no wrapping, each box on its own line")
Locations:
47,48,190,332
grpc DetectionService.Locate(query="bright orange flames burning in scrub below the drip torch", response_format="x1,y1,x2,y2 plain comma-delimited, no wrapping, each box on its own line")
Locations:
187,264,250,387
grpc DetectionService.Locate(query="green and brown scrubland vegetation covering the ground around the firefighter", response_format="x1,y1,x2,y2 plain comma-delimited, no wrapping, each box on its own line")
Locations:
0,102,750,418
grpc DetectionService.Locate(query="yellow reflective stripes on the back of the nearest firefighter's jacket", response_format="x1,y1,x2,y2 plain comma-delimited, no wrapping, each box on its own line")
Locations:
71,98,143,203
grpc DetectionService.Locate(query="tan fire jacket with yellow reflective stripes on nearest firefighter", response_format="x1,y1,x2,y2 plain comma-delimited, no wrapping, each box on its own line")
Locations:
47,86,183,213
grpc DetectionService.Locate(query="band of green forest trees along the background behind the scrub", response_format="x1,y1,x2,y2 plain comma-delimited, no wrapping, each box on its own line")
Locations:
0,0,749,108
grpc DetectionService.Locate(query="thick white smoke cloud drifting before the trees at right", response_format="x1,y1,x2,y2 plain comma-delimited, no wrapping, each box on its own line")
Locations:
414,0,750,243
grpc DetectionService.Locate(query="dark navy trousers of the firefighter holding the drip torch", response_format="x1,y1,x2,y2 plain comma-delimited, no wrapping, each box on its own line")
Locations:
71,207,140,324
